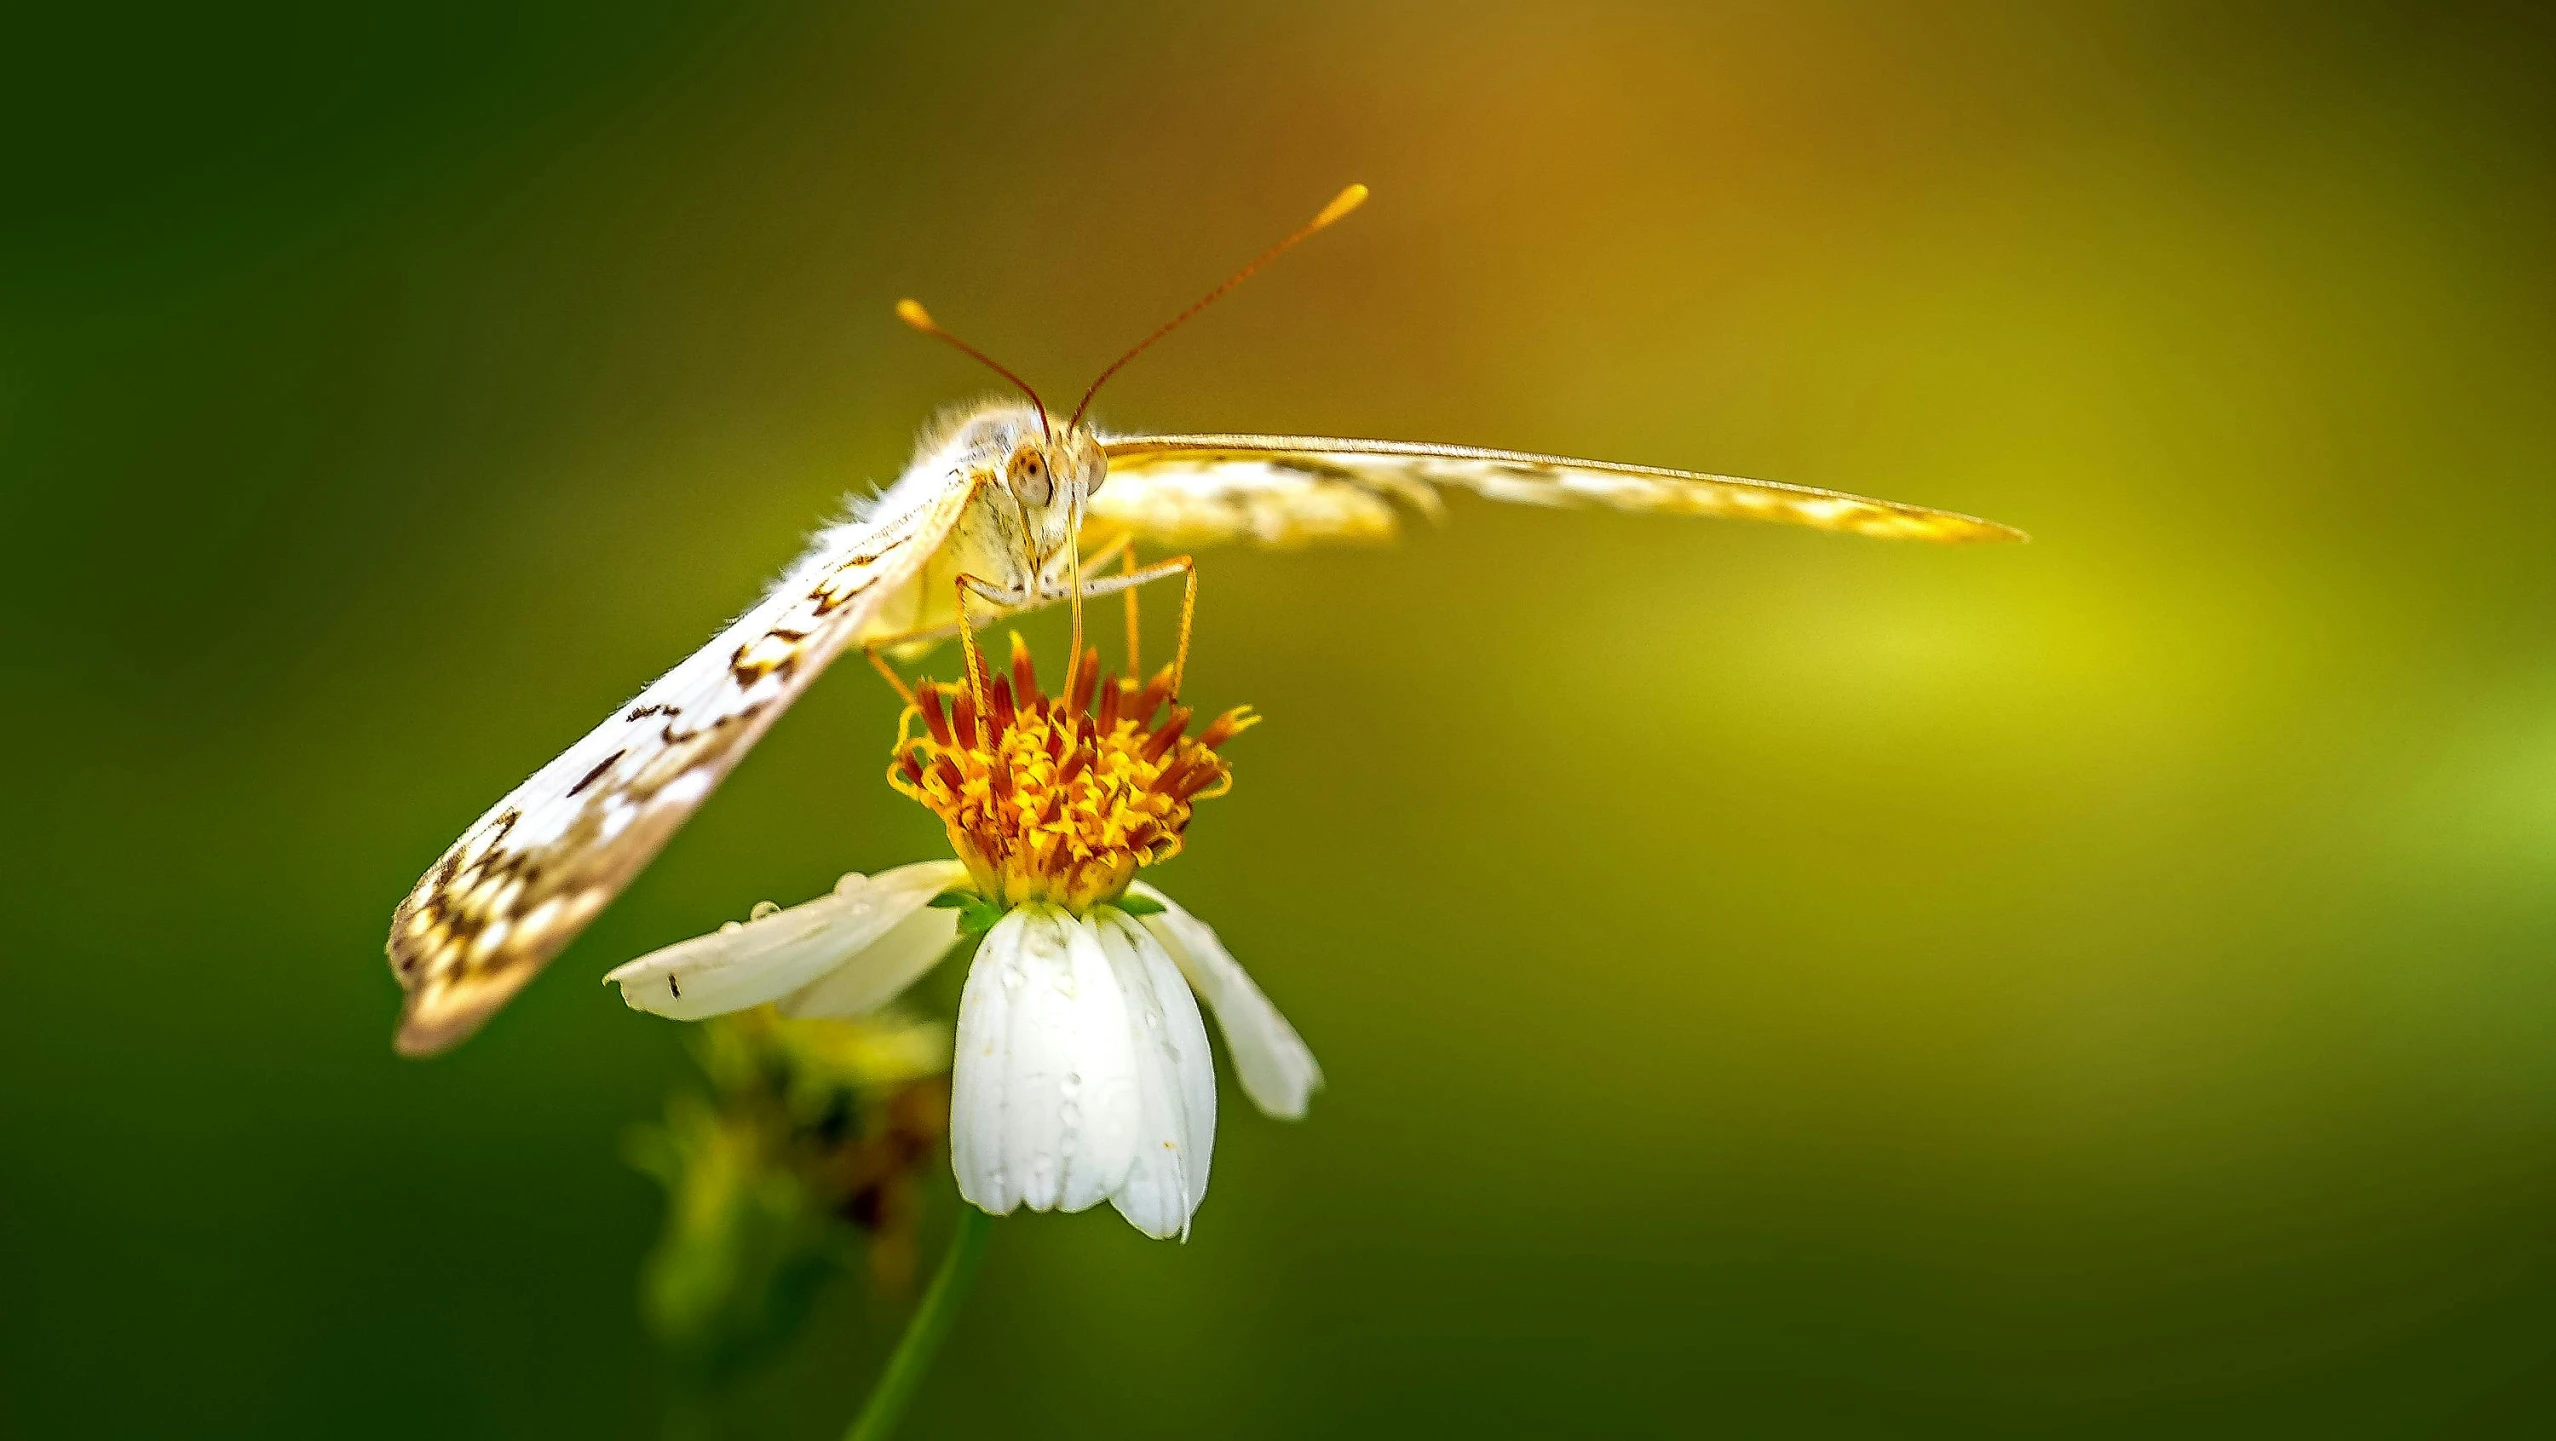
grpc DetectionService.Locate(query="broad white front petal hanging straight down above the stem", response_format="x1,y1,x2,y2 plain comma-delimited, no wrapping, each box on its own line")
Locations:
951,907,1143,1216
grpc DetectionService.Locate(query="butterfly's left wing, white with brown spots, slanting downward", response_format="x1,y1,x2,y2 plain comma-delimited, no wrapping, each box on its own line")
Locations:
389,488,966,1055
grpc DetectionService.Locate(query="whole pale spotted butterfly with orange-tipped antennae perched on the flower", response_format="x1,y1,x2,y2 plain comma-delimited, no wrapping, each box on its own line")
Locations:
389,187,2022,1055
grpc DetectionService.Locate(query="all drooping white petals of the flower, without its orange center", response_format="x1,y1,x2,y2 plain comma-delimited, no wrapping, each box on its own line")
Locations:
606,861,1321,1237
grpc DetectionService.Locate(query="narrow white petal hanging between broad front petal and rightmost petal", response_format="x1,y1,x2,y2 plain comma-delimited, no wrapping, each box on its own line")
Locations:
1089,910,1217,1239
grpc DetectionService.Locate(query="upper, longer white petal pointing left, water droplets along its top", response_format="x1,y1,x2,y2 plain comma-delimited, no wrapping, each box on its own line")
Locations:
603,861,966,1019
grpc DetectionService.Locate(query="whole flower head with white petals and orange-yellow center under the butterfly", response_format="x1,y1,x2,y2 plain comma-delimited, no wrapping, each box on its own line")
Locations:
606,641,1321,1237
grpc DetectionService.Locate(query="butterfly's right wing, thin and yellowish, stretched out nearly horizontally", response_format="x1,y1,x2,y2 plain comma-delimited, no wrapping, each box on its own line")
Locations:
1091,434,2024,547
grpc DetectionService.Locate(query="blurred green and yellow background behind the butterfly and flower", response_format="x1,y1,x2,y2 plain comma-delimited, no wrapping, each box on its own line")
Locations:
0,0,2556,1438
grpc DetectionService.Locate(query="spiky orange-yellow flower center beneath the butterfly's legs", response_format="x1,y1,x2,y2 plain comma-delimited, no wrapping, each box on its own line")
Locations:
887,634,1260,912
